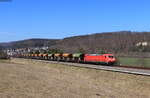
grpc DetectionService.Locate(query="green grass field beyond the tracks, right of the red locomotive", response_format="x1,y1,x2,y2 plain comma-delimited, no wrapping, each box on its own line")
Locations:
118,57,150,68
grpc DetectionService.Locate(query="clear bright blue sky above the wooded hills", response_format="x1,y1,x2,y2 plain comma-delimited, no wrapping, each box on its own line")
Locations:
0,0,150,42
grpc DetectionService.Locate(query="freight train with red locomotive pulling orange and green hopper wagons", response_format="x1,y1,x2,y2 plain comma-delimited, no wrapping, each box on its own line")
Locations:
17,53,117,65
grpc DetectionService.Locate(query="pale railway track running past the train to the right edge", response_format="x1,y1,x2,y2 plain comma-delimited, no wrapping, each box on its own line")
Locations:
20,59,150,76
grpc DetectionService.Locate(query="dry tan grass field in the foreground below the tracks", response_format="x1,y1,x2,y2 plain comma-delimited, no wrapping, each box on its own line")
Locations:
0,59,150,98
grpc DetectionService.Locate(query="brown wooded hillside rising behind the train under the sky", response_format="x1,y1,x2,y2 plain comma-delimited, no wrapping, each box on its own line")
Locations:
0,31,150,56
